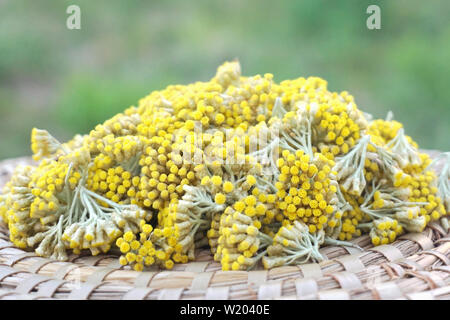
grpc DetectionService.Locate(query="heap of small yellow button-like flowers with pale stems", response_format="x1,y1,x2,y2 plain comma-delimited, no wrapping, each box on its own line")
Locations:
0,61,450,271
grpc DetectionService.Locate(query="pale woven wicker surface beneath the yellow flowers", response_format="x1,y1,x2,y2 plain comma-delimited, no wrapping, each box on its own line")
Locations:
0,152,450,300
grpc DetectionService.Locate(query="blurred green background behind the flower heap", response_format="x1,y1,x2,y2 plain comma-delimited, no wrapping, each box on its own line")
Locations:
0,0,450,159
